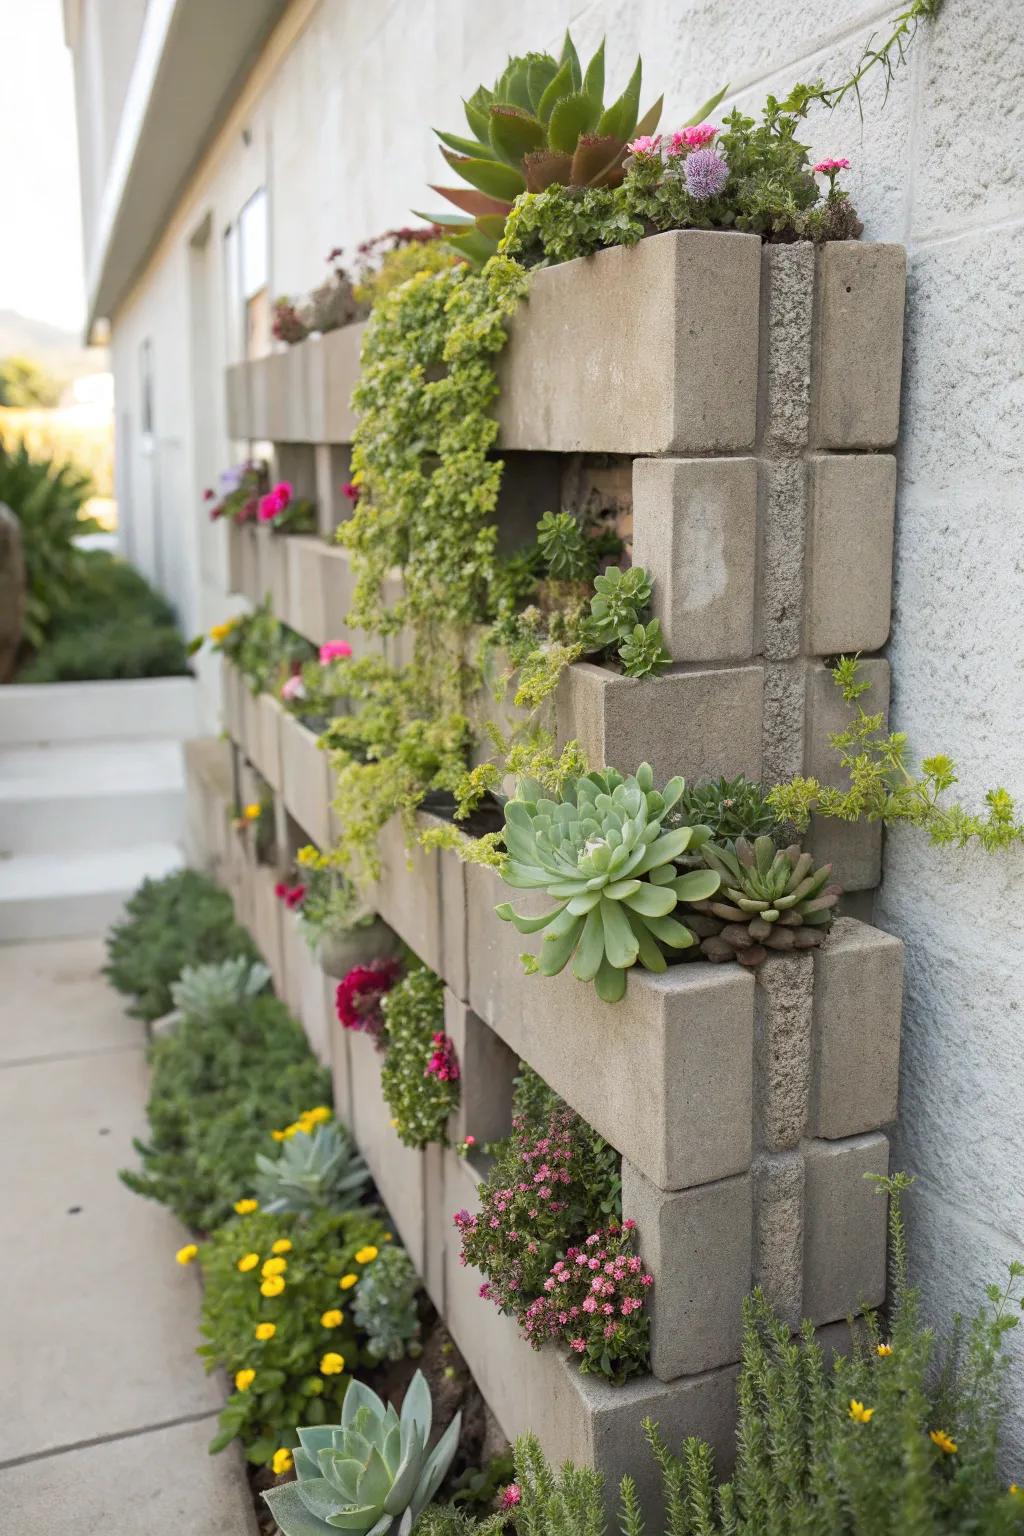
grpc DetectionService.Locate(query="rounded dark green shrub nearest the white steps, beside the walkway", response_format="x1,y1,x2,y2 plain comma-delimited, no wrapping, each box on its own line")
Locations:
104,869,259,1020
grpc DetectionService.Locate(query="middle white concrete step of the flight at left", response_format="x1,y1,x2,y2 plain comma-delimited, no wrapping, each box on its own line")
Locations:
0,740,184,857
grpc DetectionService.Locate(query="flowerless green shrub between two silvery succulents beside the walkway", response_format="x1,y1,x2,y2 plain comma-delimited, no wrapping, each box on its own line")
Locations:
121,997,330,1232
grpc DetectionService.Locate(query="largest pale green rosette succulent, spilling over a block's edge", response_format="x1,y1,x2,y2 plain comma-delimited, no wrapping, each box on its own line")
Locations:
496,763,720,1003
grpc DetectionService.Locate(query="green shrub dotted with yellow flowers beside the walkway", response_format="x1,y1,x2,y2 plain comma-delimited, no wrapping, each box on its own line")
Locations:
200,1210,384,1465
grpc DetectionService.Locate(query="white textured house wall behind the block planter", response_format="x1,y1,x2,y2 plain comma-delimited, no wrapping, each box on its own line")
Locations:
70,0,1024,1470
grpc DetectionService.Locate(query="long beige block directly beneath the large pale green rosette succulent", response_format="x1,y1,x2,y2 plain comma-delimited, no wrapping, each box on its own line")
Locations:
465,865,754,1189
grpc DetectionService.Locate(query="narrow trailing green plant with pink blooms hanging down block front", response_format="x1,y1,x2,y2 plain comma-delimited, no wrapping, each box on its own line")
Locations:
381,966,459,1147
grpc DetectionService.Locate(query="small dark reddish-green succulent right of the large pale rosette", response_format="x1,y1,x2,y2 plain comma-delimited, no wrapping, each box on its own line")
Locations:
680,837,841,966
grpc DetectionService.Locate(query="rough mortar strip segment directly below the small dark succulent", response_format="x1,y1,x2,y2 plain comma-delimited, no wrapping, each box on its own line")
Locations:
754,954,810,1152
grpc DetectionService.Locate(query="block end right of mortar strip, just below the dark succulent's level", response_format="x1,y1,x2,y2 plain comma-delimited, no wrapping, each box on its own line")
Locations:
808,917,903,1140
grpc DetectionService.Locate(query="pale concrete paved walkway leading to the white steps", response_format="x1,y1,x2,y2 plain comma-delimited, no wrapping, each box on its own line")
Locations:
0,938,255,1536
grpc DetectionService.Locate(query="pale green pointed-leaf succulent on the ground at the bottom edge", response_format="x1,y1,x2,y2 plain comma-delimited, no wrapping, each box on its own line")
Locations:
263,1370,462,1536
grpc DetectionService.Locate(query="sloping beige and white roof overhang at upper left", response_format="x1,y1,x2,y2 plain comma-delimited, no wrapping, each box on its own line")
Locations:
86,0,287,333
